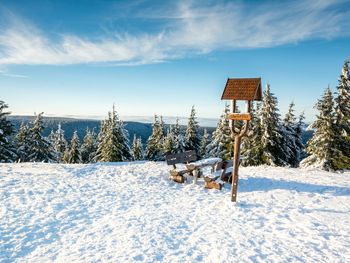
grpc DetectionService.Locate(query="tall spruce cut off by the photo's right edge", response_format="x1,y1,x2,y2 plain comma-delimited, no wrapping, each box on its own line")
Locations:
334,61,350,169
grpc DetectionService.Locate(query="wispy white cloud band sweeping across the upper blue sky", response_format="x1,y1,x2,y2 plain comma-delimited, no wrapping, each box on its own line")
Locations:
0,0,350,65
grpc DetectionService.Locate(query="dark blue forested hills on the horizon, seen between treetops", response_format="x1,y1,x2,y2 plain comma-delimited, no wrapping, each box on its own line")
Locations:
9,115,214,142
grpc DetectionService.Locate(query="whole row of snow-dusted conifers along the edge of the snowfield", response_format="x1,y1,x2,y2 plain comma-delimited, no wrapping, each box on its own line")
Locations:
0,61,350,170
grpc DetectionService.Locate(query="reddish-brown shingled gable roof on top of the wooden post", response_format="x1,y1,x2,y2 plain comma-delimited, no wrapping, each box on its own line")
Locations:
221,78,262,100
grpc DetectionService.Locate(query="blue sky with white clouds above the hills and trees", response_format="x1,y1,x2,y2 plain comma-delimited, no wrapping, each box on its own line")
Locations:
0,0,350,125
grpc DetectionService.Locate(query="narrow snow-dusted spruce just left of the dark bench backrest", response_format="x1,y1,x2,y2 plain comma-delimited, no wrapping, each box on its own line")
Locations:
146,115,164,161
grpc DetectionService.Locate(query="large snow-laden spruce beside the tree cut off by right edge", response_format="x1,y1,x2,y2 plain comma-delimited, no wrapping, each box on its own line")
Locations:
300,87,339,171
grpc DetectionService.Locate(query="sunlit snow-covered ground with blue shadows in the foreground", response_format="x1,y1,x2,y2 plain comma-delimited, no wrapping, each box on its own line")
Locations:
0,162,350,262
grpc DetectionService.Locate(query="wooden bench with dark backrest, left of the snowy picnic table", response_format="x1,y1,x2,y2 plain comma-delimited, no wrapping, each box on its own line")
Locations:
165,150,197,183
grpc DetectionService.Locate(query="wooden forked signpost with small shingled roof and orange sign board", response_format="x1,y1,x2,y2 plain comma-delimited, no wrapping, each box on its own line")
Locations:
221,78,262,202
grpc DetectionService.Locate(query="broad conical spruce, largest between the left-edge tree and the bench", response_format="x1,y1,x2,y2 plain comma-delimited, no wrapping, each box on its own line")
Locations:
96,106,131,162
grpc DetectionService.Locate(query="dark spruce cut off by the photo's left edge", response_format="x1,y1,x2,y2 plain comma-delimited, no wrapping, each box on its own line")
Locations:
0,100,17,163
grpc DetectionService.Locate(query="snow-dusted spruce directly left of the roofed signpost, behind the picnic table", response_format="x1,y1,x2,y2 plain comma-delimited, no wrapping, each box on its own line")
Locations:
206,106,233,160
